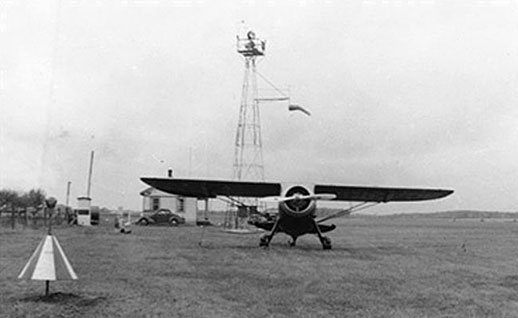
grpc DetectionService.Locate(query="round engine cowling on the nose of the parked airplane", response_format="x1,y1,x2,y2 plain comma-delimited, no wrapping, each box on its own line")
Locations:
279,185,316,218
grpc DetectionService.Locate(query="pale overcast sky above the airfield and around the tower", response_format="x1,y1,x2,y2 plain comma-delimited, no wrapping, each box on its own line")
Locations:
0,0,518,212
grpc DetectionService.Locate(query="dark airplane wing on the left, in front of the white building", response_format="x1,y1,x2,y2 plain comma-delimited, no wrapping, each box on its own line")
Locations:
140,178,281,198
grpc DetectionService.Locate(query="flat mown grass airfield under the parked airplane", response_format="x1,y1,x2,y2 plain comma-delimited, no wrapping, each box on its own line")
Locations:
0,217,518,317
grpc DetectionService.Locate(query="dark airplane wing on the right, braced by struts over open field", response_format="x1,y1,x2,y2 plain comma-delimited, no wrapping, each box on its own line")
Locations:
315,184,453,202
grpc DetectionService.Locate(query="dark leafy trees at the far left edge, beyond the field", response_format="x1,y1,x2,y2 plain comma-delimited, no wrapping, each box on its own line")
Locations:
0,189,45,210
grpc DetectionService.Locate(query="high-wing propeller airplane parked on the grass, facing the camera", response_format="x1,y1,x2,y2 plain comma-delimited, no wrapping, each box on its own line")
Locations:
141,177,453,250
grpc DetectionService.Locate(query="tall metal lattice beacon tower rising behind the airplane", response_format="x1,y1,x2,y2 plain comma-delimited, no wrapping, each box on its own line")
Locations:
233,31,265,181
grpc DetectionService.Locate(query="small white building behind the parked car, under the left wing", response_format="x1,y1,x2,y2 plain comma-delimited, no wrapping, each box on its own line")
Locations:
140,187,198,224
